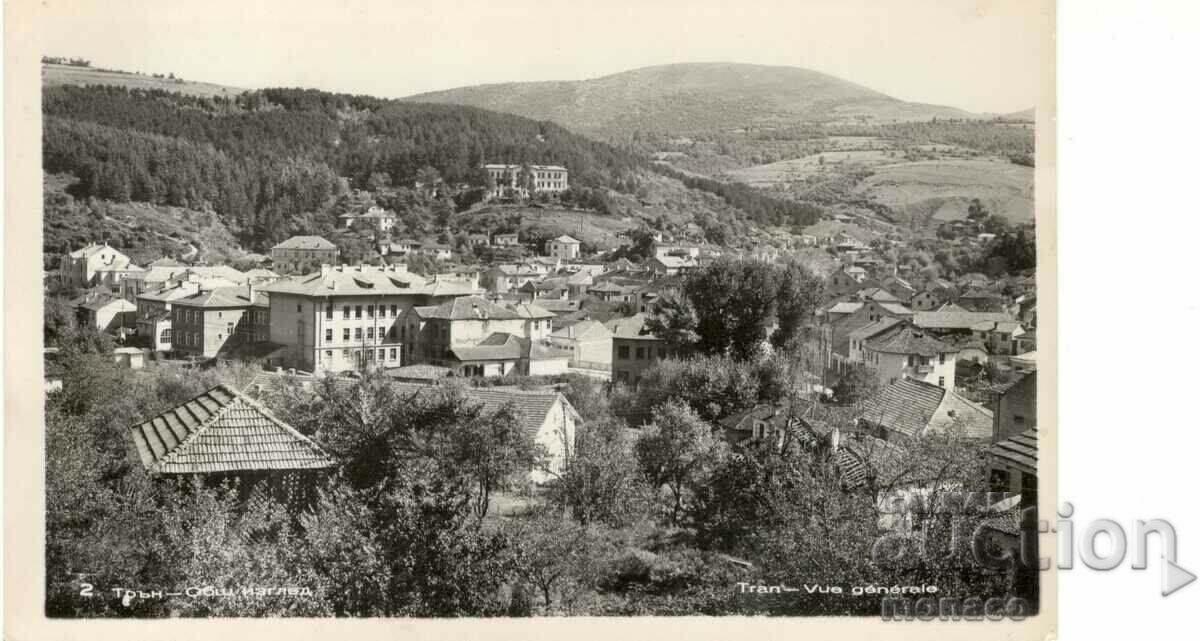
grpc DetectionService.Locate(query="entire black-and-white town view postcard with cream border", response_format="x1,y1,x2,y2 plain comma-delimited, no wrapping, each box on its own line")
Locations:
10,0,1055,639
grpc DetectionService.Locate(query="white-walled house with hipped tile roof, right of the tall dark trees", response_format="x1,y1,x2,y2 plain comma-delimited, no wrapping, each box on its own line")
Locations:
852,322,959,391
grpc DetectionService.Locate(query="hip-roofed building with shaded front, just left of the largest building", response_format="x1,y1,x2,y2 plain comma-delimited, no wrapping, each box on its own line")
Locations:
170,284,271,358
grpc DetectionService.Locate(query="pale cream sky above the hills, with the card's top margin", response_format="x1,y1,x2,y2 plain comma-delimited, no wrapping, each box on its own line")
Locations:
41,0,1052,113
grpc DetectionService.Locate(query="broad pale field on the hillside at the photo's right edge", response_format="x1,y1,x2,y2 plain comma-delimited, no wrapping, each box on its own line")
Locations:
854,160,1033,223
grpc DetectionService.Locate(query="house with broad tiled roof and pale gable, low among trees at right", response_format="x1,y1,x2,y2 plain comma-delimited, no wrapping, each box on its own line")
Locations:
856,378,992,442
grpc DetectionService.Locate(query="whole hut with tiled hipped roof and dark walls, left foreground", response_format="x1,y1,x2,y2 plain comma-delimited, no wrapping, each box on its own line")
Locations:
130,385,336,508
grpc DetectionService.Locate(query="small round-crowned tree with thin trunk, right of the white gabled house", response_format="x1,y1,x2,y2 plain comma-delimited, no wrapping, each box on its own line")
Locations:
634,401,725,523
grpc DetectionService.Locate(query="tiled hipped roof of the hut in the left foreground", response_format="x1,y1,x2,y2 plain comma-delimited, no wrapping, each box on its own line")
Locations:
130,385,335,474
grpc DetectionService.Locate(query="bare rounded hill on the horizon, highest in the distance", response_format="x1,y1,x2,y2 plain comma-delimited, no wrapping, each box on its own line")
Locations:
406,62,973,139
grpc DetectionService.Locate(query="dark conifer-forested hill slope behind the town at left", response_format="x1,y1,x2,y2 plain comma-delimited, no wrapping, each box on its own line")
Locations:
42,85,816,250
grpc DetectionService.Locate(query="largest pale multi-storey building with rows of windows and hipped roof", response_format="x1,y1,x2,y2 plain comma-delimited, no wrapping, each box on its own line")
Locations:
264,264,479,372
